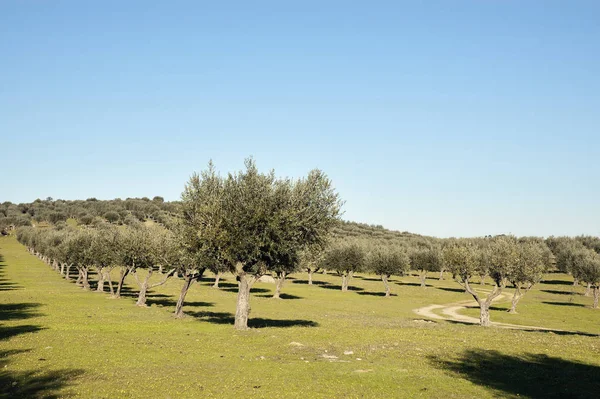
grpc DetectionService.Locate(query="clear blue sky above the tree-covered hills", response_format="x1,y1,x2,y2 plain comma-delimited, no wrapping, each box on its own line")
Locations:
0,0,600,236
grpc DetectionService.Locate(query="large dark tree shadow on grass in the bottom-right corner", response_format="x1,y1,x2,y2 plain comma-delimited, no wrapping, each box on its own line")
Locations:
429,349,600,399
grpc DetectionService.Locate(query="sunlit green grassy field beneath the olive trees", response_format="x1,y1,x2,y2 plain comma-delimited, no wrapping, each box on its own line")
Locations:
0,237,600,398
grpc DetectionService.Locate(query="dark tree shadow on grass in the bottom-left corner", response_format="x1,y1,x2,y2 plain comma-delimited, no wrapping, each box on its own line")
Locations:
0,350,84,399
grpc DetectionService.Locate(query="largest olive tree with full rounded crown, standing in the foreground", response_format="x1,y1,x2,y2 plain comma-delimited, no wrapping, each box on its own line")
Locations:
182,159,341,330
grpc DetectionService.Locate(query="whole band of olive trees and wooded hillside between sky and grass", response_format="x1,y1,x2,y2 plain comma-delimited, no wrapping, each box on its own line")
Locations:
7,159,600,329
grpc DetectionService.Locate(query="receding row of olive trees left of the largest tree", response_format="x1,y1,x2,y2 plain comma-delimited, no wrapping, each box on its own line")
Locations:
17,225,202,316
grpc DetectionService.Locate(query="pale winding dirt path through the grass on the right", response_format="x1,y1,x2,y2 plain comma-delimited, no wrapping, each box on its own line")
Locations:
413,290,564,331
